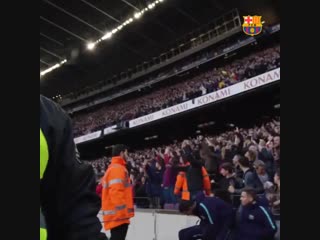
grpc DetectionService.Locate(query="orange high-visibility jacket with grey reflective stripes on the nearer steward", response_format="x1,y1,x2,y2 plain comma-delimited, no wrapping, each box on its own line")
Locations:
101,157,134,230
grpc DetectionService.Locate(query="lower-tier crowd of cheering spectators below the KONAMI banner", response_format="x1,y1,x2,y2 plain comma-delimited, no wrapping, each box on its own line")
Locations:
87,118,280,215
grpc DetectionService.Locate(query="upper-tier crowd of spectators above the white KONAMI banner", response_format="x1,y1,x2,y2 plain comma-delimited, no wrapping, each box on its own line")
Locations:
73,45,280,136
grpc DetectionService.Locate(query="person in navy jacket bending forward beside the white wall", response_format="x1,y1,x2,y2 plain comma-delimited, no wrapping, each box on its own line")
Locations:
179,193,234,240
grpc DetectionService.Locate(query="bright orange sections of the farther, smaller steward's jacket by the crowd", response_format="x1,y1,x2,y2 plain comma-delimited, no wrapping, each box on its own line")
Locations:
174,167,211,200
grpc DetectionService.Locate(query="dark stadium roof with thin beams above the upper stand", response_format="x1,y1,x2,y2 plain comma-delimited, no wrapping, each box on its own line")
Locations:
40,0,279,97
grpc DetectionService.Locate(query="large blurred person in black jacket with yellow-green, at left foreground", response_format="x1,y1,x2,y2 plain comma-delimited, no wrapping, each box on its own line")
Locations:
40,95,107,240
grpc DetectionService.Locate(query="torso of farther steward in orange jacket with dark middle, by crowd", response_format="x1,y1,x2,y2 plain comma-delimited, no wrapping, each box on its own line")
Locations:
174,159,211,200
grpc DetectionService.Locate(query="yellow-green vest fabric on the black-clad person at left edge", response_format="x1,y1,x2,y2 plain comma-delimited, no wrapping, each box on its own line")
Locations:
40,128,49,240
